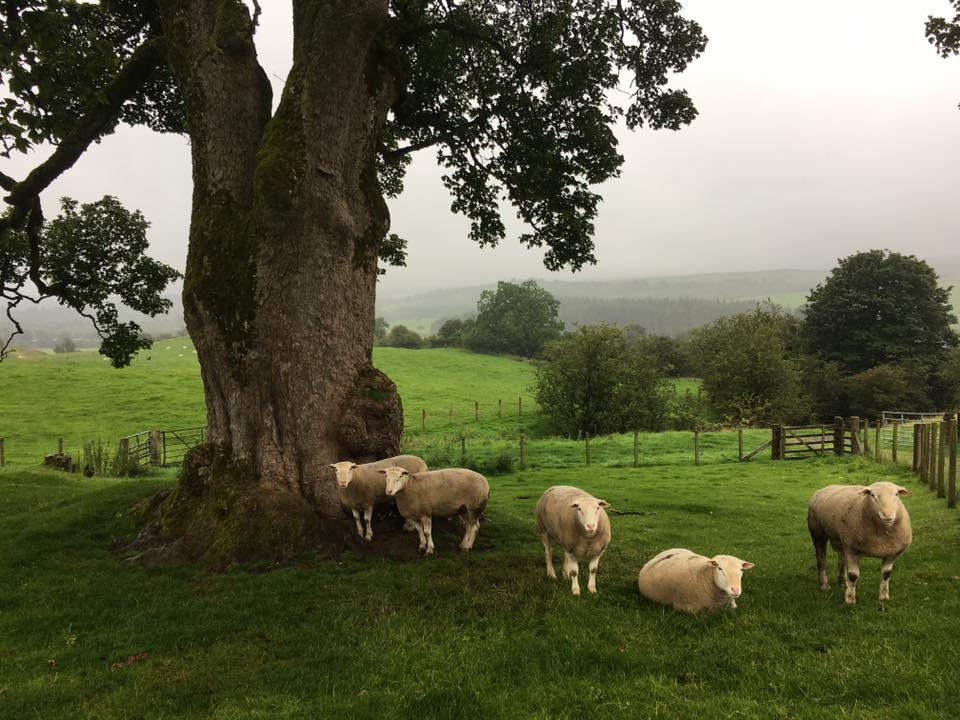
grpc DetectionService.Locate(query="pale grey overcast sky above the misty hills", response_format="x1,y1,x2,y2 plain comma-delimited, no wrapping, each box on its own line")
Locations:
4,0,960,294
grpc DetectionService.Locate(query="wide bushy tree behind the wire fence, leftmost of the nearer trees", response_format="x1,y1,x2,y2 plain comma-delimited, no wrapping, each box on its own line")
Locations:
536,325,668,436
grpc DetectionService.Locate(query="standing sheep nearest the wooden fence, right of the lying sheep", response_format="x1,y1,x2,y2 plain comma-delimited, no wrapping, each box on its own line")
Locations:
807,482,913,605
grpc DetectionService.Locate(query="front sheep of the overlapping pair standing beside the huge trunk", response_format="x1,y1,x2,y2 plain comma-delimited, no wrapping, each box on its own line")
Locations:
380,467,490,555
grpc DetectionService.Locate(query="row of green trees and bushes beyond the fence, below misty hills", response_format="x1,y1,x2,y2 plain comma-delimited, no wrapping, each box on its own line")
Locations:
378,250,960,435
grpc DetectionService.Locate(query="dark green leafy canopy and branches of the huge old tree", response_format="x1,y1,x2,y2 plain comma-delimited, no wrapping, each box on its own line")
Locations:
0,0,706,364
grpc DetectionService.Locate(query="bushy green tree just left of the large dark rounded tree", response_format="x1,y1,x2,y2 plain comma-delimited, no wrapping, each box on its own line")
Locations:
689,305,809,425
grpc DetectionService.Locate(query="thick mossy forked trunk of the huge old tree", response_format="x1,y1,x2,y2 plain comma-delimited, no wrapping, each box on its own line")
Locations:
139,0,402,565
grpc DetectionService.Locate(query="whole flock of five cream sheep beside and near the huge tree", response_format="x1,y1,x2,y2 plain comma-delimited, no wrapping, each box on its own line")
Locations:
330,455,912,613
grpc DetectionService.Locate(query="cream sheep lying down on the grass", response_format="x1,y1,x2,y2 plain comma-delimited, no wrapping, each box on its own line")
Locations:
637,548,753,614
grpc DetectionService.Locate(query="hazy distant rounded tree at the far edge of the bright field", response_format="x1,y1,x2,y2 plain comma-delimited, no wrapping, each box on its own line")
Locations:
467,280,563,357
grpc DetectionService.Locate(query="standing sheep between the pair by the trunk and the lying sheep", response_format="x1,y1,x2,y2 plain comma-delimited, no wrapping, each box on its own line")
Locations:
537,485,610,595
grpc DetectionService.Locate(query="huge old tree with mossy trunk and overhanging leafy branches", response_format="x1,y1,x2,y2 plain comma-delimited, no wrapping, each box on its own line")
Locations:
0,0,706,564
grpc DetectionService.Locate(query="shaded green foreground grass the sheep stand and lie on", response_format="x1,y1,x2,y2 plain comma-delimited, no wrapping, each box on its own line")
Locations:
0,458,960,720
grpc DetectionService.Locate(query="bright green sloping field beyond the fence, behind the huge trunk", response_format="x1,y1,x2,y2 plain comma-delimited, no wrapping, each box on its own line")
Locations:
0,338,699,465
